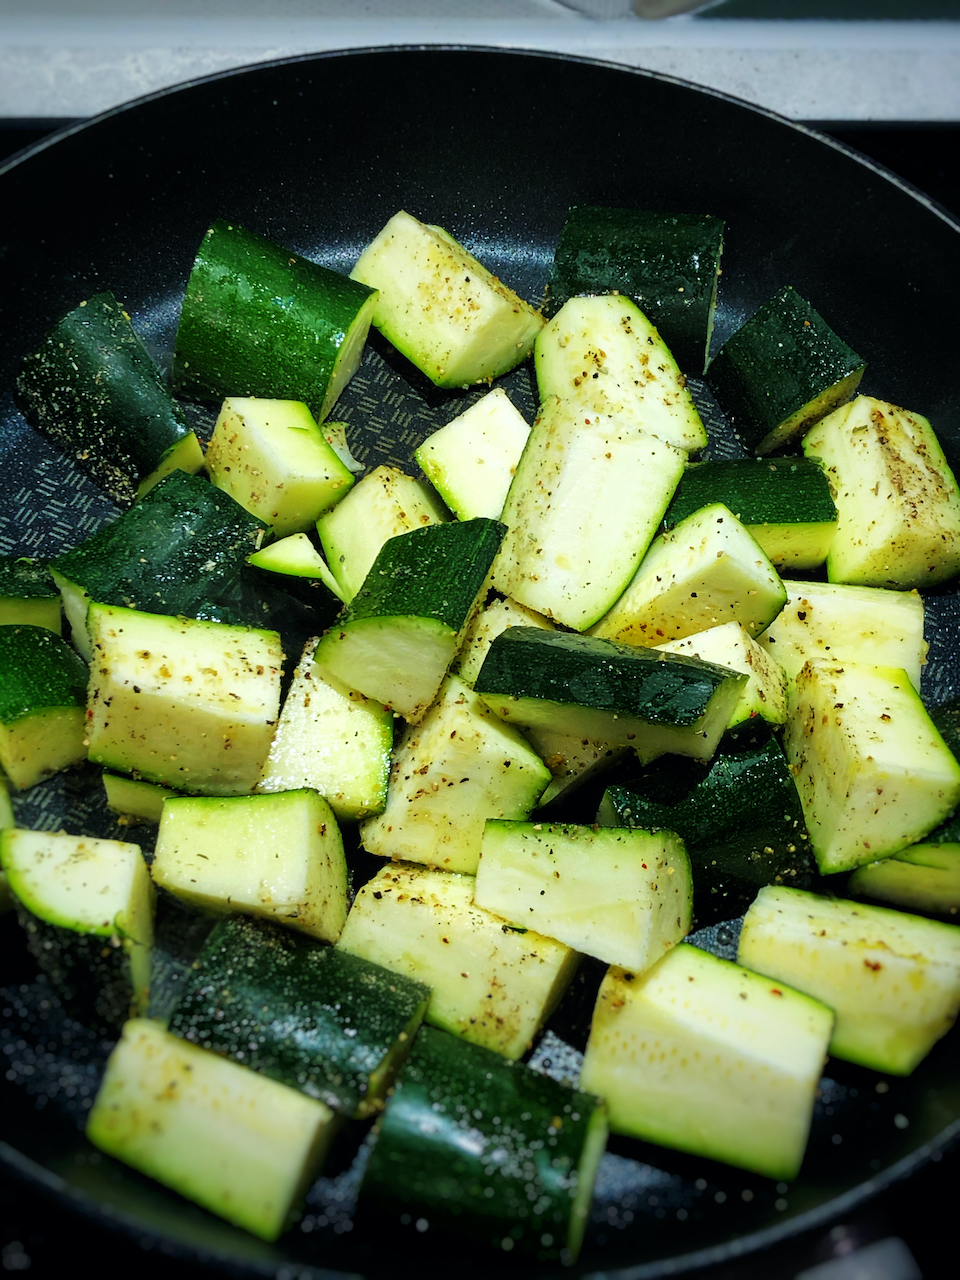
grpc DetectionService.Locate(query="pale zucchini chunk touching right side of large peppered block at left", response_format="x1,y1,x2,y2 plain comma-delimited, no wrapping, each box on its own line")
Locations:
257,640,393,822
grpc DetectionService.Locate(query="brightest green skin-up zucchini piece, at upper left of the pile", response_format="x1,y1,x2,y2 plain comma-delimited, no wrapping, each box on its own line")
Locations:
173,221,376,421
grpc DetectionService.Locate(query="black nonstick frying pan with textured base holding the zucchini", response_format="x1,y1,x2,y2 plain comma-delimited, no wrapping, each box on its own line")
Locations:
0,47,960,1280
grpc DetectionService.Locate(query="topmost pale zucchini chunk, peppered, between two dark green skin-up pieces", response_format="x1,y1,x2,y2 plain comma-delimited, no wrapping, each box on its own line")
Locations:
351,210,543,387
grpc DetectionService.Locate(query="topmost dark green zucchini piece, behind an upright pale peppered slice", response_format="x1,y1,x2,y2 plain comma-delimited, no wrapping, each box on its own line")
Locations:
544,205,723,375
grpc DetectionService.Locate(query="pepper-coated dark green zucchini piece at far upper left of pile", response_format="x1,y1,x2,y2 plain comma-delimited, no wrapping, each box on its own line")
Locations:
17,293,204,503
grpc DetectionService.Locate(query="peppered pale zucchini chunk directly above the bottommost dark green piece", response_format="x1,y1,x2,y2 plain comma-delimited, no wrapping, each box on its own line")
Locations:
338,863,580,1059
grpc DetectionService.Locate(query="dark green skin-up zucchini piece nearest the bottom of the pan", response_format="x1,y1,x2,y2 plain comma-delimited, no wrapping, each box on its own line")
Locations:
360,1027,607,1262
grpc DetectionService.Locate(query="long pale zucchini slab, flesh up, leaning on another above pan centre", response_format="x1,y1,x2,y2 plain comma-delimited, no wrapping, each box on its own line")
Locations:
494,397,684,631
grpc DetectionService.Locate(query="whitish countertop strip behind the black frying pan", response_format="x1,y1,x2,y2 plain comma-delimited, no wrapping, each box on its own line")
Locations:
0,0,960,120
